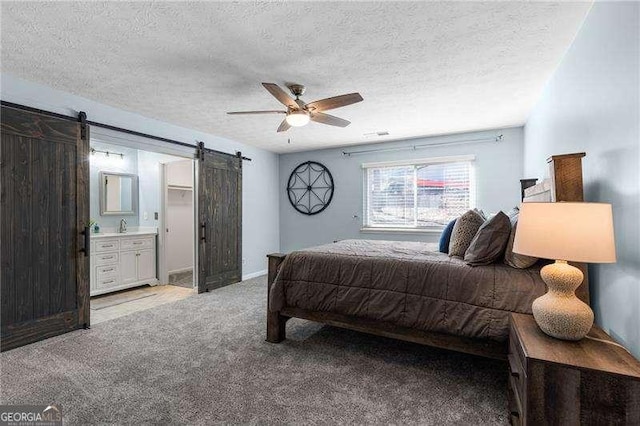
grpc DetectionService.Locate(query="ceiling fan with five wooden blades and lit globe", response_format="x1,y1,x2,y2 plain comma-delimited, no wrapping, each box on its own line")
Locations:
227,83,362,132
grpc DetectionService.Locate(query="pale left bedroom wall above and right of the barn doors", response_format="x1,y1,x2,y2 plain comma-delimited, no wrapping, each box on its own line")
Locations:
0,73,279,277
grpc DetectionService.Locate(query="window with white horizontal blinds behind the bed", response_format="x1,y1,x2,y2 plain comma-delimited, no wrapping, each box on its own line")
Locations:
362,156,475,229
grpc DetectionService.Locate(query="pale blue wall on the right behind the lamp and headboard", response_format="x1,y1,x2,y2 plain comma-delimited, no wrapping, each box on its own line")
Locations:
524,2,640,357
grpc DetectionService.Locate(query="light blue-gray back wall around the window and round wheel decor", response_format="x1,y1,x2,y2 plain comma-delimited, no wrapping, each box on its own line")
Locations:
279,128,523,252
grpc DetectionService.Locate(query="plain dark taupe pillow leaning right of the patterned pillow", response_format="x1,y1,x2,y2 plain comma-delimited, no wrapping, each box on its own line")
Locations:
464,212,511,266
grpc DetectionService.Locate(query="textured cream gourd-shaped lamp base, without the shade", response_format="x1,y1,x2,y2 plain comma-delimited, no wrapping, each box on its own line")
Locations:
532,260,593,340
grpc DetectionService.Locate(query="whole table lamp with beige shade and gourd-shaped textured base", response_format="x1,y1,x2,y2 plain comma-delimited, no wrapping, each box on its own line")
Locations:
513,202,616,340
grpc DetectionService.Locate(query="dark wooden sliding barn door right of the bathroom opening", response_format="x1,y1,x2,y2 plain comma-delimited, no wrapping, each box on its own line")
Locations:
198,146,242,293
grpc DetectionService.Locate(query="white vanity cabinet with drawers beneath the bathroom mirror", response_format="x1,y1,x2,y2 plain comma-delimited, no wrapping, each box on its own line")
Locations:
91,232,158,296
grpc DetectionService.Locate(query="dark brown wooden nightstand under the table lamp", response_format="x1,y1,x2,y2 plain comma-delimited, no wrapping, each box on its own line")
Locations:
508,314,640,425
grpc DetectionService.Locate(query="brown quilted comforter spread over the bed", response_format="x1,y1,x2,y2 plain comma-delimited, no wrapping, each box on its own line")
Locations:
269,240,545,340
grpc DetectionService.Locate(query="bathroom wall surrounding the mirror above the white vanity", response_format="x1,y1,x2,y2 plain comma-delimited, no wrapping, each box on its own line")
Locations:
89,141,139,232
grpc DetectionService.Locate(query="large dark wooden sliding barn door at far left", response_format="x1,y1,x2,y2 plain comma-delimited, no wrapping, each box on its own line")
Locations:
0,106,89,351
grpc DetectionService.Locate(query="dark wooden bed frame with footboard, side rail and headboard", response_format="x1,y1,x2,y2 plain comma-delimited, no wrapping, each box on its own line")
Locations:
267,153,589,360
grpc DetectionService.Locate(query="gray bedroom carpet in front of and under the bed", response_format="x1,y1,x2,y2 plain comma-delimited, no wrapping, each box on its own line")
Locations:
0,277,508,424
